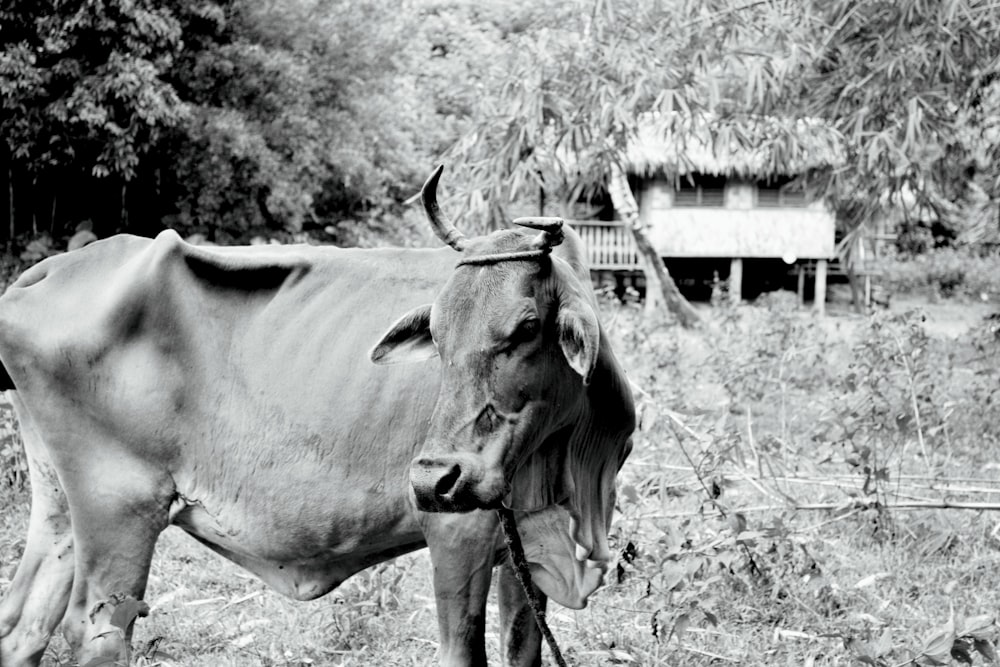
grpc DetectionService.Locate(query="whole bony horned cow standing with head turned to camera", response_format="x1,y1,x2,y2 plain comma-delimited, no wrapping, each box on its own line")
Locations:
0,167,635,667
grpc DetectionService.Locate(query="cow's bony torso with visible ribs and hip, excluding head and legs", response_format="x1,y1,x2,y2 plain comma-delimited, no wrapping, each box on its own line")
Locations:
0,232,454,597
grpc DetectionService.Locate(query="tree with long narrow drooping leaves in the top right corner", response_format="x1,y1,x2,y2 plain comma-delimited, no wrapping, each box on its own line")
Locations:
773,0,1000,250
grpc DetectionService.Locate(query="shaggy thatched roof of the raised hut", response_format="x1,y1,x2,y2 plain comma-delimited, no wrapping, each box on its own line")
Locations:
628,114,845,179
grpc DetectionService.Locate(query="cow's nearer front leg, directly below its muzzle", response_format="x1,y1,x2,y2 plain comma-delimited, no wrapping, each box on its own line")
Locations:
424,511,499,667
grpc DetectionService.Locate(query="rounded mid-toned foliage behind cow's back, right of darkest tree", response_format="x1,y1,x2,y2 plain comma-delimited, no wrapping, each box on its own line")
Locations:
162,0,433,236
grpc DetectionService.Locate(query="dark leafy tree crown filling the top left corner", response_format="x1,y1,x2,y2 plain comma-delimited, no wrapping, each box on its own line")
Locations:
0,0,187,178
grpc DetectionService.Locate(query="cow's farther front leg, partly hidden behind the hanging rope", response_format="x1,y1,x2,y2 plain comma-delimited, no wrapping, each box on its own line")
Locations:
497,557,547,667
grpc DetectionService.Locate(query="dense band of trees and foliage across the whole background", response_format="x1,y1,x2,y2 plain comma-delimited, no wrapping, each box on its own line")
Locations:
0,0,1000,255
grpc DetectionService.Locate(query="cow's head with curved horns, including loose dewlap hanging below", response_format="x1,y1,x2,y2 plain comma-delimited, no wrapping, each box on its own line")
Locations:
371,167,623,607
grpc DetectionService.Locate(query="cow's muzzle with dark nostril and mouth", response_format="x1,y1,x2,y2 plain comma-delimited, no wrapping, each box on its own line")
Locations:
410,454,507,512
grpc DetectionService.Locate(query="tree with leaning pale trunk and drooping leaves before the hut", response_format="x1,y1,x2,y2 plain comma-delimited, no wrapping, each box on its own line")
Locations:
446,0,804,326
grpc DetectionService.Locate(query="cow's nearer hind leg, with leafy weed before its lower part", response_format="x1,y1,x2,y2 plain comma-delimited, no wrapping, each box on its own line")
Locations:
52,442,173,665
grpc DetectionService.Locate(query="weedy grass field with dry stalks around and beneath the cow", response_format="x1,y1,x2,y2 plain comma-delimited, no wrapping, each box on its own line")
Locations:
0,294,1000,667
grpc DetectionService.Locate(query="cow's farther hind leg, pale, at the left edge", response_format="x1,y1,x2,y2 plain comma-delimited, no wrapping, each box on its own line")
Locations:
0,398,74,667
